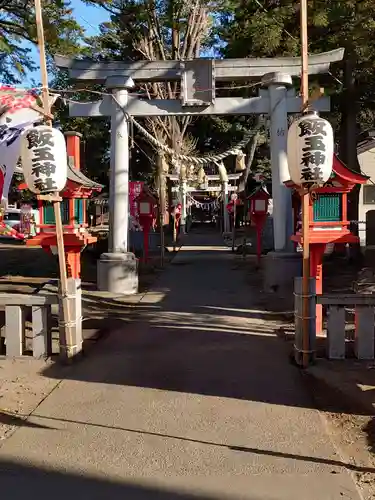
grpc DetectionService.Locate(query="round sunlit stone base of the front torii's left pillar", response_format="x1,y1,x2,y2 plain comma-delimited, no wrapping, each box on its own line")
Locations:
97,252,138,295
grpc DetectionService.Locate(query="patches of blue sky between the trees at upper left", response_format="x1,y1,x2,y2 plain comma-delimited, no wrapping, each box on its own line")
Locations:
23,0,109,87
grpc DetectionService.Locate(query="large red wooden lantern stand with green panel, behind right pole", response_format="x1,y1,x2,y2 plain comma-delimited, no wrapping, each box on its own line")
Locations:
285,156,368,334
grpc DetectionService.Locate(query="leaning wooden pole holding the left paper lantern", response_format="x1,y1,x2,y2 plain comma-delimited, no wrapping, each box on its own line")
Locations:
34,0,73,359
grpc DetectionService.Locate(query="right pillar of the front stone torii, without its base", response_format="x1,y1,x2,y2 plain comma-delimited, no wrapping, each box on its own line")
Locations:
262,73,293,251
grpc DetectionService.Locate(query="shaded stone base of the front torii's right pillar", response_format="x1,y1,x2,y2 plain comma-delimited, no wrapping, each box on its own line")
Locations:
262,252,302,293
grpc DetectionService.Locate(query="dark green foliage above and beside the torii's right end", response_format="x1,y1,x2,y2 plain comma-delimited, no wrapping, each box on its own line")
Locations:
217,0,375,172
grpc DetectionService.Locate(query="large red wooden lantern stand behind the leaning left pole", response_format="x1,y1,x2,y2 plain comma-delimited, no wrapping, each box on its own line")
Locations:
18,132,102,278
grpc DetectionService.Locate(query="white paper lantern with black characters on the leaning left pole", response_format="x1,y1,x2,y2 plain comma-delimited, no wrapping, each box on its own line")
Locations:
21,125,68,194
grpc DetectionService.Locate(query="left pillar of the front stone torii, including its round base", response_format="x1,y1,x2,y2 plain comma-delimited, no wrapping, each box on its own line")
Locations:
97,77,138,295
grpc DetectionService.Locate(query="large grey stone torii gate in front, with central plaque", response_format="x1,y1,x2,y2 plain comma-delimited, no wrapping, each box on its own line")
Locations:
55,49,344,294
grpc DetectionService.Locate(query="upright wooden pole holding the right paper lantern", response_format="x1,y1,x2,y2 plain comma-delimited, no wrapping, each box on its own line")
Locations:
300,0,310,368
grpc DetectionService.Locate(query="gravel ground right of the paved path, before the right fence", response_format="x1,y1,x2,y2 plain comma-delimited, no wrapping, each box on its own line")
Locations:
305,359,375,500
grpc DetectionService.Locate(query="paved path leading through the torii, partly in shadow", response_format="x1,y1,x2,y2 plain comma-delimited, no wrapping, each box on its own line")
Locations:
0,230,359,500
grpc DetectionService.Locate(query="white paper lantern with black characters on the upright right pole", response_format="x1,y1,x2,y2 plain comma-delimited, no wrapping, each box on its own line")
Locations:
288,112,334,186
